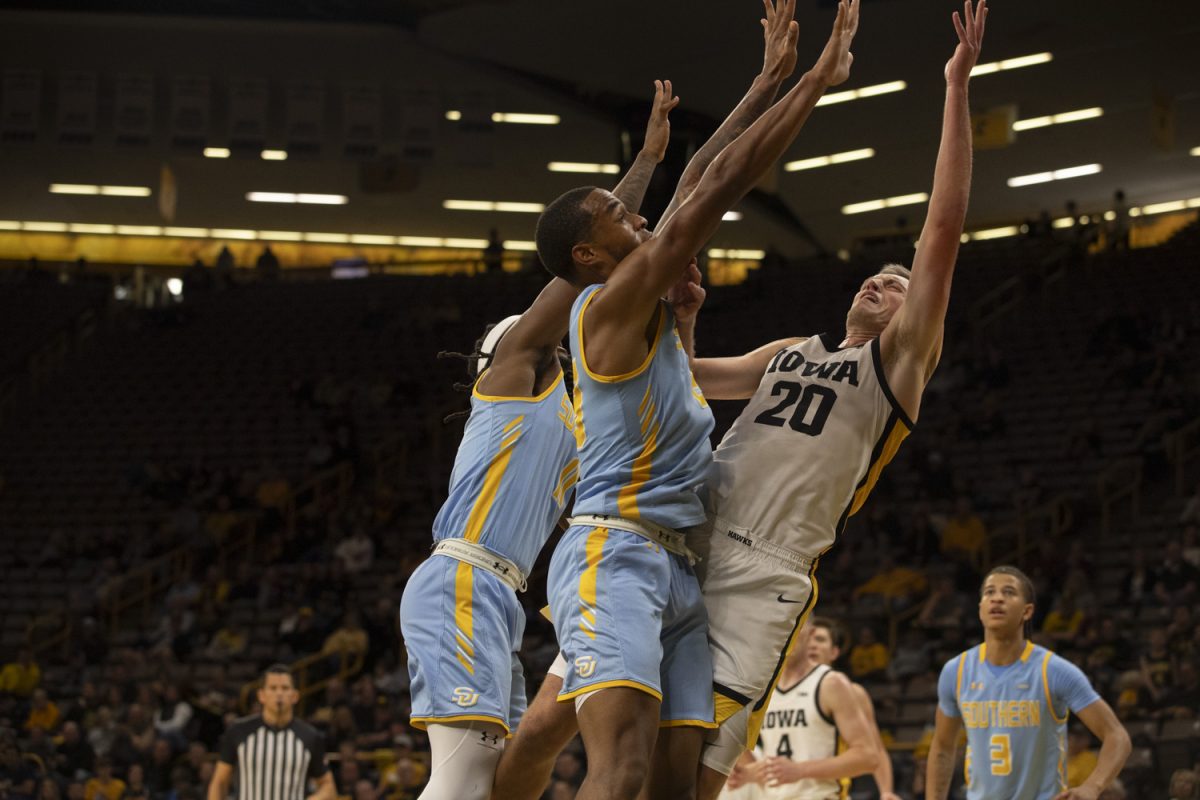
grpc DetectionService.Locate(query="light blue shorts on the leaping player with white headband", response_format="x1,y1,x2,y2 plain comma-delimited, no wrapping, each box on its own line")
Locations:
400,555,526,732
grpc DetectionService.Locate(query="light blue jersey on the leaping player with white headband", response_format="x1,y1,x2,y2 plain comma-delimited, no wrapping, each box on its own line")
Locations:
433,375,578,575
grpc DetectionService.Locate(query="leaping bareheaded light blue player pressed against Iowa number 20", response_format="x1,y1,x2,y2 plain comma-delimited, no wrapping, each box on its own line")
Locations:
536,0,858,800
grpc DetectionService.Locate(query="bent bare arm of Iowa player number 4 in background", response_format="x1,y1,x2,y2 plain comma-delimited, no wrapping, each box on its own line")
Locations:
762,672,880,786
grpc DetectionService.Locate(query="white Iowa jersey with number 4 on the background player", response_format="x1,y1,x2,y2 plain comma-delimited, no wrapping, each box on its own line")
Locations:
758,664,850,800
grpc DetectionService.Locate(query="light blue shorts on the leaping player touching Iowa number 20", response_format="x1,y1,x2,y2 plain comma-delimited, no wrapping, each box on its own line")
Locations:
547,525,716,728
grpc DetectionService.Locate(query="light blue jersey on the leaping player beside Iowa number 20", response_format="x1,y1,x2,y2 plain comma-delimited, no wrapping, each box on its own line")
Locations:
570,284,714,530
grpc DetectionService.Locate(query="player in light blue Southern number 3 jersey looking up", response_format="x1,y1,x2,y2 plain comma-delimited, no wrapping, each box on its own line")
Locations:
925,566,1130,800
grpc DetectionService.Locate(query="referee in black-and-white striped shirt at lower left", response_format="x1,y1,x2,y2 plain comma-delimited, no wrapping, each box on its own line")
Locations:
208,664,337,800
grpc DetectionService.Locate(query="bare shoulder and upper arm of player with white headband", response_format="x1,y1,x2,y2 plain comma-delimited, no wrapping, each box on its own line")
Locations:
479,278,580,397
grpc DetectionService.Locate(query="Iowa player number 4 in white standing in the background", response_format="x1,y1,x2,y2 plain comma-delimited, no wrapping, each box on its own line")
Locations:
710,618,896,800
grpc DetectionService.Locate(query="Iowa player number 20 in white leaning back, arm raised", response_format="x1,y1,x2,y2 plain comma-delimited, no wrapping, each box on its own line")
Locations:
690,0,988,800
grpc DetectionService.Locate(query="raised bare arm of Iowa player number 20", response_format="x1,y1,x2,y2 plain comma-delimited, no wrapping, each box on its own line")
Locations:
880,0,988,419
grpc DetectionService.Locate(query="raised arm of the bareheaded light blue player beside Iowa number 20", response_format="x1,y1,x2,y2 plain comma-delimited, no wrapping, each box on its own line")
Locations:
587,0,858,335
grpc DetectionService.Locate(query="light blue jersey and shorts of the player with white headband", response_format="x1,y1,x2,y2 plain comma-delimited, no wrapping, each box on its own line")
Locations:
400,375,578,732
